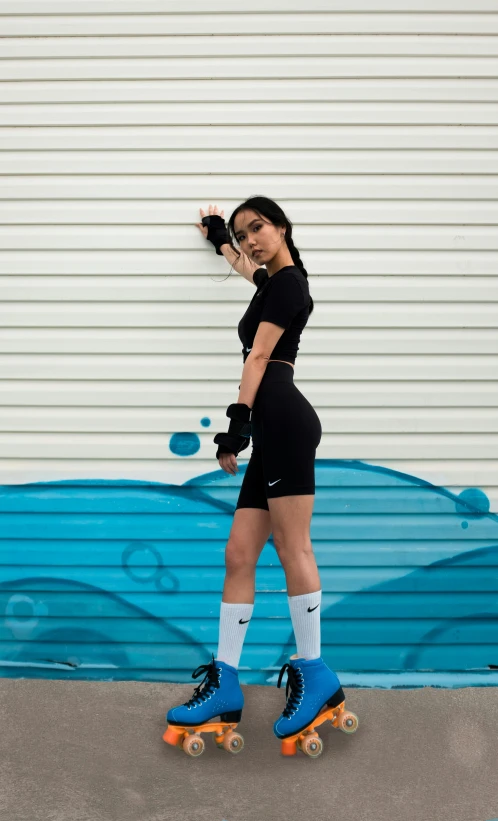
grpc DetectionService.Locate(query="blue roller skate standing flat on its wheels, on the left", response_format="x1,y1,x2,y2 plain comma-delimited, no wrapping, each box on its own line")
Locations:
163,653,244,756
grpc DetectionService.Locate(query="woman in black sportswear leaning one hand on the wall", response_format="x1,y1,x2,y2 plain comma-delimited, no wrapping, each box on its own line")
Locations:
166,197,344,752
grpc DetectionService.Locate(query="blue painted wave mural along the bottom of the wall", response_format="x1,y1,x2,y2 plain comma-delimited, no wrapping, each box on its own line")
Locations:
0,462,498,686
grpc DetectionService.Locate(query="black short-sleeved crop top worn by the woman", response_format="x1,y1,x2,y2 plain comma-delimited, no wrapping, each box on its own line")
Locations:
238,265,310,364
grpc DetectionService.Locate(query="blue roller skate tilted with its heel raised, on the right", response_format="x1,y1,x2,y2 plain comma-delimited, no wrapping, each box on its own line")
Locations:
273,654,358,758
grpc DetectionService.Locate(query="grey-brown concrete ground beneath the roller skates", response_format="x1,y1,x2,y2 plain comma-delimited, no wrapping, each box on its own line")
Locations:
0,679,498,821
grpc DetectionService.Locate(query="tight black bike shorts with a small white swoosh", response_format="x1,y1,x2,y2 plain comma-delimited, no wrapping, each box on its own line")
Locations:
235,361,322,510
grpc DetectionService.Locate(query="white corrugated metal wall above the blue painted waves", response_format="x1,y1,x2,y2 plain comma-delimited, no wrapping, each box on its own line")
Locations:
0,0,498,684
